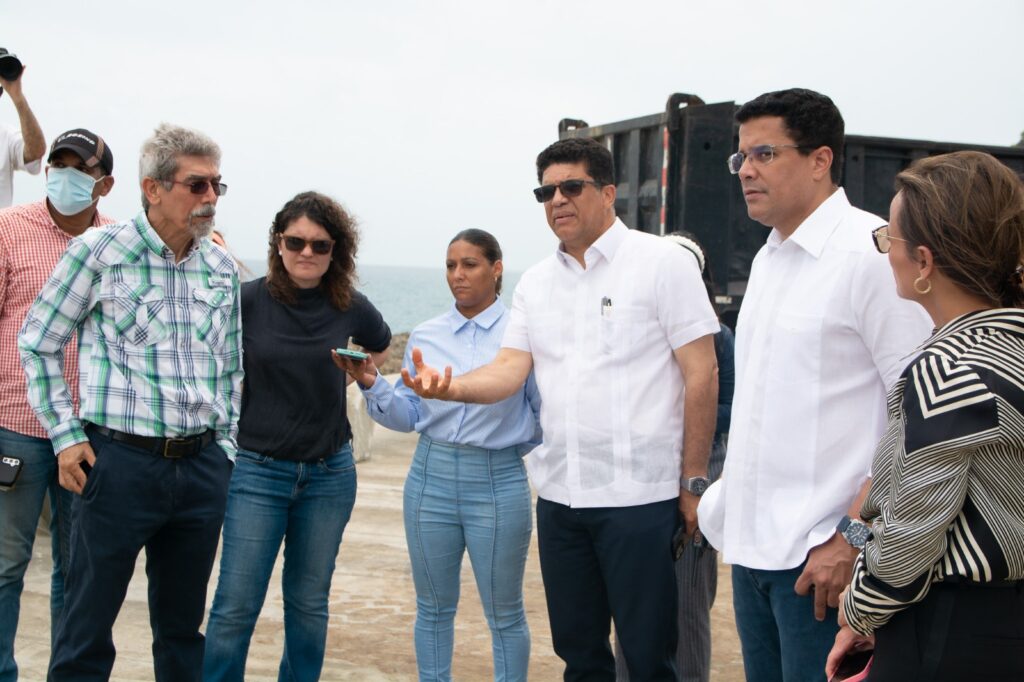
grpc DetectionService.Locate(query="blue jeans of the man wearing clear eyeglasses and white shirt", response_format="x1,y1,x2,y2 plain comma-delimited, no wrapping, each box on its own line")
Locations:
732,564,839,682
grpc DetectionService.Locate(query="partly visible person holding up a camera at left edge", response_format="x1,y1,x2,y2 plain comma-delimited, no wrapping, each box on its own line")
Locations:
0,47,46,209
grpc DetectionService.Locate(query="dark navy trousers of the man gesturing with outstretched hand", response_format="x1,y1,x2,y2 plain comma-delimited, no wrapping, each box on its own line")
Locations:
537,498,679,682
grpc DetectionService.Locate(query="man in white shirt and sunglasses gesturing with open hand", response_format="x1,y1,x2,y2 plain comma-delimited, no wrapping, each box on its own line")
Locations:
402,139,719,682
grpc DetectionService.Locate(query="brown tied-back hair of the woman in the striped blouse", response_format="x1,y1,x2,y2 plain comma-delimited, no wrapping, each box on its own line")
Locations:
896,152,1024,307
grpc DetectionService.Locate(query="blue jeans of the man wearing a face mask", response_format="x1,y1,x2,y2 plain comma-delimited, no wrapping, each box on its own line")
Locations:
0,421,72,682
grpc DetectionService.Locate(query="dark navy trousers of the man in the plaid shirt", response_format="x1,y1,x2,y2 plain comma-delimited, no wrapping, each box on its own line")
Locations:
49,429,231,682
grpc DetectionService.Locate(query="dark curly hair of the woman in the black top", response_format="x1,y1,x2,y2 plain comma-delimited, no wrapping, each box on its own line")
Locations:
266,191,359,310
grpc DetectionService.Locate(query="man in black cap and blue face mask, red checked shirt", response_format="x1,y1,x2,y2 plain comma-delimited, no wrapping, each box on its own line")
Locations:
0,128,114,682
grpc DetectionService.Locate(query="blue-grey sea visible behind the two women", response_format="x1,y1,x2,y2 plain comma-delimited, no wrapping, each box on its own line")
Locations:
242,258,521,334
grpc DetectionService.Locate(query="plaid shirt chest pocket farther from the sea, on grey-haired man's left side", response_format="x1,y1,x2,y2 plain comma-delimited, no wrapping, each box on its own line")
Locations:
101,282,171,347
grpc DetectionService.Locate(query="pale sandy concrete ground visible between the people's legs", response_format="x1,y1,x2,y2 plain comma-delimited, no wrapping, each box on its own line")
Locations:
9,421,743,682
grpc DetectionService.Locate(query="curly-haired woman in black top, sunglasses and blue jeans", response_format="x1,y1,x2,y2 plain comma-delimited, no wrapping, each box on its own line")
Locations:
203,191,391,680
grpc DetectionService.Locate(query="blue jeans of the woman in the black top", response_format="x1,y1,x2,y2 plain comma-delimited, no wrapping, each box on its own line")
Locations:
203,443,355,682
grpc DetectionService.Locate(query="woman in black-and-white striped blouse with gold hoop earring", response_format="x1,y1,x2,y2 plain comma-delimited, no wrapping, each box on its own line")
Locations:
825,152,1024,682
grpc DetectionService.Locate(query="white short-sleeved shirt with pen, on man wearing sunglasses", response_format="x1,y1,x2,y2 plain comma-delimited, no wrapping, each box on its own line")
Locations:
502,220,719,507
